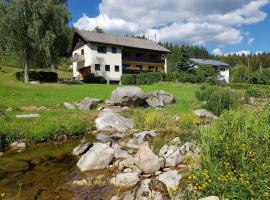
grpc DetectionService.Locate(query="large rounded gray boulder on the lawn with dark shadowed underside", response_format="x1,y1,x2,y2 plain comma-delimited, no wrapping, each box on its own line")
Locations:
110,86,146,107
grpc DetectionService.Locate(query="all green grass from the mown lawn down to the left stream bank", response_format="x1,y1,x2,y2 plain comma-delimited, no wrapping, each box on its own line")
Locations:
0,67,197,147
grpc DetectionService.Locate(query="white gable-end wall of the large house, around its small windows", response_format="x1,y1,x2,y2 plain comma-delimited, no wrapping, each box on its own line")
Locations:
73,43,122,81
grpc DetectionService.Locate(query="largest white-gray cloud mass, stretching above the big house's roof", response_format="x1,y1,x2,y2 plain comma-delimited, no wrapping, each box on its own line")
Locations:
74,0,269,46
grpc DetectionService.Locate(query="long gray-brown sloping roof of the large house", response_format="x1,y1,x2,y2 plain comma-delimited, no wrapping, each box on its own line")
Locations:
76,29,170,53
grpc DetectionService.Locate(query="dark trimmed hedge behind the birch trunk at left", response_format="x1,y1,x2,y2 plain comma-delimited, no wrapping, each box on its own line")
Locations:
16,71,58,83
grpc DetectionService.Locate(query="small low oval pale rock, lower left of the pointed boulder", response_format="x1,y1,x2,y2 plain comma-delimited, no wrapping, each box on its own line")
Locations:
111,173,140,189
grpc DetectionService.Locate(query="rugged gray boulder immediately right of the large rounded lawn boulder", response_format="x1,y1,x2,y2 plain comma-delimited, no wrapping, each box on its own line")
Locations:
146,90,176,107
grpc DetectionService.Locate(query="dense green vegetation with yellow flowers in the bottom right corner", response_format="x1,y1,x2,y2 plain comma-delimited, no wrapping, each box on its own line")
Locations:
188,108,270,199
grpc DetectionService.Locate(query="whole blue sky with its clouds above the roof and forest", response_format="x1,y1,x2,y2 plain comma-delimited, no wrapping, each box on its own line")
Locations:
68,0,270,53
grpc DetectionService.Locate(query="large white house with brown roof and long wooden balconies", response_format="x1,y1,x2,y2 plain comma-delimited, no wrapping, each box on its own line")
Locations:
68,30,170,83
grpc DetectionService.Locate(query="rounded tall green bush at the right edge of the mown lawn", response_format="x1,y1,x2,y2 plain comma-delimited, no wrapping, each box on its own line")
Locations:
196,86,240,115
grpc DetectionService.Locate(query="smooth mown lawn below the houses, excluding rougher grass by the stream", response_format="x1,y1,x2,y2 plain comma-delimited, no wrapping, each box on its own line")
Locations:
0,68,196,114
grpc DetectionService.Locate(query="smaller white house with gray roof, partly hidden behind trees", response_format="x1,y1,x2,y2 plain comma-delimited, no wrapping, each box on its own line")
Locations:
190,58,230,83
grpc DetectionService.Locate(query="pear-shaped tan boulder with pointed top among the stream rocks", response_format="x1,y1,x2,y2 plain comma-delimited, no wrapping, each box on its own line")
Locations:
134,142,160,174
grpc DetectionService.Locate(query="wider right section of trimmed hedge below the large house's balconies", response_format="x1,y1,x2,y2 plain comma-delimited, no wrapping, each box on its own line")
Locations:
136,72,164,85
